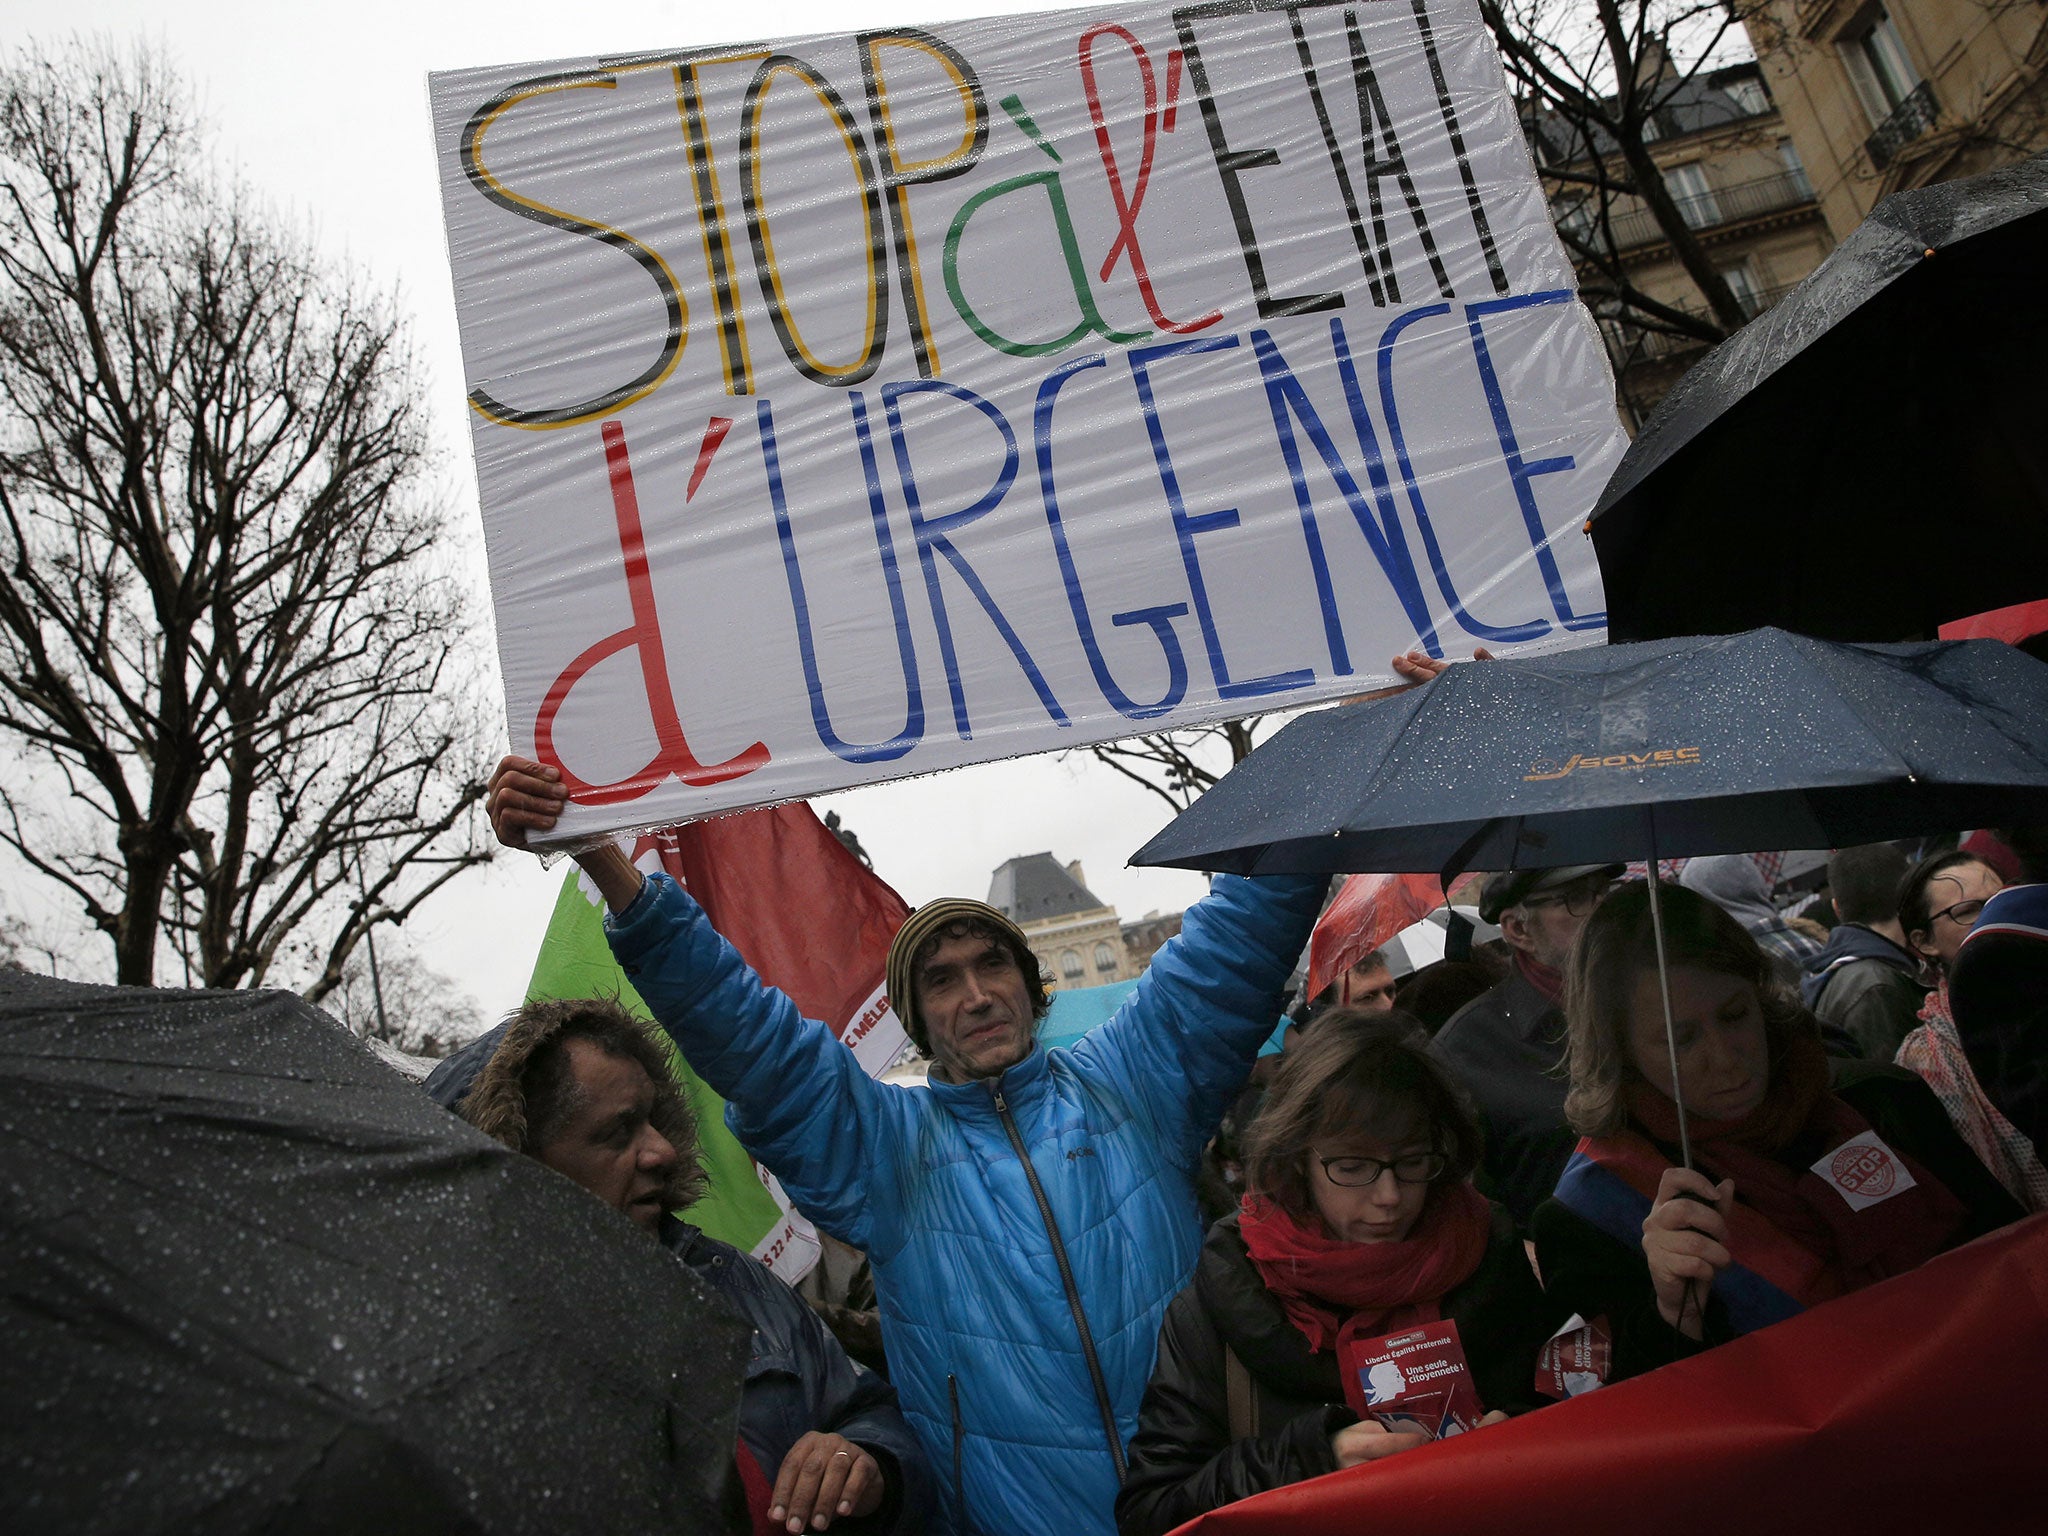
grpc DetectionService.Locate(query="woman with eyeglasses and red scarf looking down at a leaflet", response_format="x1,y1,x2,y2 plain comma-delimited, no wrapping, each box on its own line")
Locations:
1116,1008,1554,1536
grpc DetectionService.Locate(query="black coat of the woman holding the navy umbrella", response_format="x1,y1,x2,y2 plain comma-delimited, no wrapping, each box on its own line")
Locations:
1534,1061,2025,1380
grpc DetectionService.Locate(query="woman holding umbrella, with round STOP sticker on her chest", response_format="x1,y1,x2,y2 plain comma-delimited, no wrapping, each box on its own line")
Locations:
1532,885,2021,1378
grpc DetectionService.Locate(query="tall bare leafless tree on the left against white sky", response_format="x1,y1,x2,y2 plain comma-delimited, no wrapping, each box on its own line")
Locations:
0,45,492,991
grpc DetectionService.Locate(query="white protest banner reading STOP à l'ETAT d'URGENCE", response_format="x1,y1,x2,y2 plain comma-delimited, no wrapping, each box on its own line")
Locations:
432,0,1622,842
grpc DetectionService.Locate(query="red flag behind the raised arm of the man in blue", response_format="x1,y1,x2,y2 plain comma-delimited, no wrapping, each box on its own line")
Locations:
633,801,909,1075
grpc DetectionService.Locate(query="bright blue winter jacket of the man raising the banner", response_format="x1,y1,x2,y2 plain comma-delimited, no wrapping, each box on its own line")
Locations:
606,874,1325,1536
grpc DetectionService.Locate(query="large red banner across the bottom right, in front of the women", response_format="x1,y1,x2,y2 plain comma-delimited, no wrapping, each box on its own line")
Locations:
1180,1214,2048,1536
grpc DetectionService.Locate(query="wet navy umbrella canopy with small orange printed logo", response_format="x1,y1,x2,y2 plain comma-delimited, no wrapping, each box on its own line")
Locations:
1130,629,2048,874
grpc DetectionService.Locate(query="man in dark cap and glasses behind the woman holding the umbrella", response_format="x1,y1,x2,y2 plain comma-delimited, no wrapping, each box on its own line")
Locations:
1430,864,1622,1227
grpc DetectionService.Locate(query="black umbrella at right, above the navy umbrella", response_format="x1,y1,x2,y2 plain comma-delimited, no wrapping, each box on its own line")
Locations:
1589,156,2048,641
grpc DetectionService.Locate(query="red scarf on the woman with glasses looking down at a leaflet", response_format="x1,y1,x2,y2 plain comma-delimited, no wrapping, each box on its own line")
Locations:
1237,1184,1493,1352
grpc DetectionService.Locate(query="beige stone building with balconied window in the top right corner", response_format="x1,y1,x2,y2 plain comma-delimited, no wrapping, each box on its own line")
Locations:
1745,0,2048,240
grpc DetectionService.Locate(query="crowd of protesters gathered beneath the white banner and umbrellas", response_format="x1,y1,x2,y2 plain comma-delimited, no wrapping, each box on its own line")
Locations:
444,688,2048,1536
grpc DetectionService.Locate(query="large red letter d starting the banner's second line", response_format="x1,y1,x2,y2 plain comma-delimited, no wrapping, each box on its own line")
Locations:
532,422,768,805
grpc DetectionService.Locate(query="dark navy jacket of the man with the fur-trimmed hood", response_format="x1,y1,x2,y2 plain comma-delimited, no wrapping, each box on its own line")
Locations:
662,1217,932,1536
